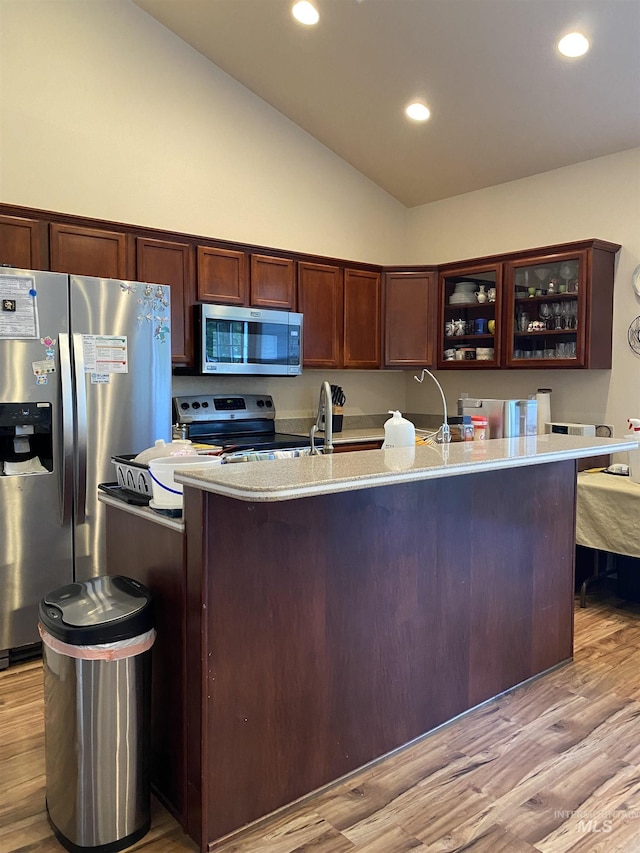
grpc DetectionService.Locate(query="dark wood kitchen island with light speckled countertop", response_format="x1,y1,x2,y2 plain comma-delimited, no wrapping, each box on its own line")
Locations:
101,435,635,850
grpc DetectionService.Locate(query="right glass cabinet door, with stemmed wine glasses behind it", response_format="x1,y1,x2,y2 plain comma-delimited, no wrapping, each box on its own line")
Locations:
505,252,586,367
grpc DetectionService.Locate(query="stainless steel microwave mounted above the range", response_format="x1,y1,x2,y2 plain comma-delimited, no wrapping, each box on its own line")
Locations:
196,303,302,376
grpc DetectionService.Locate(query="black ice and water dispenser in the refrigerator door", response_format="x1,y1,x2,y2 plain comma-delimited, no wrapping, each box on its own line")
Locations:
0,403,53,476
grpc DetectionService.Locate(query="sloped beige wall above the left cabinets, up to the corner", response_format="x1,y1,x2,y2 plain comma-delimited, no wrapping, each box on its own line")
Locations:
0,0,406,263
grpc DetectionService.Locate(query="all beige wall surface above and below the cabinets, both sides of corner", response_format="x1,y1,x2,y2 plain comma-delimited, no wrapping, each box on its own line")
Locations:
0,0,640,433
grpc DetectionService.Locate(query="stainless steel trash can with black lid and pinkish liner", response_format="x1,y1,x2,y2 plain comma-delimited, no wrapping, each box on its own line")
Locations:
39,576,155,853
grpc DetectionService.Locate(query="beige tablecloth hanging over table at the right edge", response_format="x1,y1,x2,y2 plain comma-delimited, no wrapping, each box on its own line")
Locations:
576,471,640,557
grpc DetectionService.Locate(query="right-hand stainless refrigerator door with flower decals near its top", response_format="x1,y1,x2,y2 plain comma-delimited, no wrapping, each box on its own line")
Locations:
70,276,171,580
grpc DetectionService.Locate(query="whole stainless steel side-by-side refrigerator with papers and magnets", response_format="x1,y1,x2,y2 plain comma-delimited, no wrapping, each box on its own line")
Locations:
0,267,171,669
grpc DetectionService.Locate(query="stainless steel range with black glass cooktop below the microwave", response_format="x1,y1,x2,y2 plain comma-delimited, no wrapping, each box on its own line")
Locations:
173,394,322,451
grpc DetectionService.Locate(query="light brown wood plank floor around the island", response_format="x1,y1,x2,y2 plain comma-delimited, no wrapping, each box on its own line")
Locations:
0,584,640,853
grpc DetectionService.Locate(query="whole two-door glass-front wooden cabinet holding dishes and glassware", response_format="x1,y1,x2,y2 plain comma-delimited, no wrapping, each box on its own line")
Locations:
438,240,620,369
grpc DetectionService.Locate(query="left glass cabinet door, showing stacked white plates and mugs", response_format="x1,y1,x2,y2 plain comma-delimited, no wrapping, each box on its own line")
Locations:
438,264,502,369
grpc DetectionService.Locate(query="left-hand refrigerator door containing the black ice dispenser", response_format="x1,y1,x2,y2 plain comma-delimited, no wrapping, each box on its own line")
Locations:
0,268,73,665
